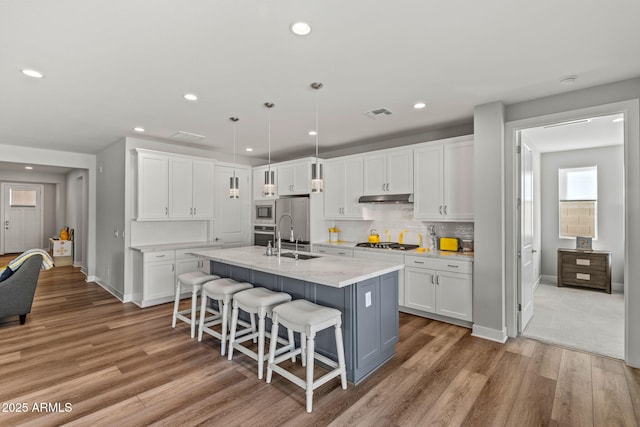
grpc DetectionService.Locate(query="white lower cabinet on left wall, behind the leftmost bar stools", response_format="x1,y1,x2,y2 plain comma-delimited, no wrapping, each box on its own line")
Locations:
133,247,213,307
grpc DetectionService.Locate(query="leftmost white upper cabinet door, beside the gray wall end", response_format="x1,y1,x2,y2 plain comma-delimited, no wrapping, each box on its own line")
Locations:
134,152,169,219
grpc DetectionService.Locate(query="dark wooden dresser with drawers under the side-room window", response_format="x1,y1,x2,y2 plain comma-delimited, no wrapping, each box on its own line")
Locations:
558,249,611,293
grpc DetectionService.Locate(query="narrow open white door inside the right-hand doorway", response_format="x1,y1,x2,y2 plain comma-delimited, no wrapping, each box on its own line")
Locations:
518,143,535,333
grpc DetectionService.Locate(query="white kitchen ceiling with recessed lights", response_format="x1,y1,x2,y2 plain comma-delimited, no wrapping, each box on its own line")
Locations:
0,0,640,164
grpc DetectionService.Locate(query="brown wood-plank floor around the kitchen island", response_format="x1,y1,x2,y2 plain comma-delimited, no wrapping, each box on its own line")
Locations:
0,257,640,427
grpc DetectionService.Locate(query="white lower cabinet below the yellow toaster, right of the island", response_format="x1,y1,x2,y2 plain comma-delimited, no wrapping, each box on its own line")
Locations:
401,255,473,322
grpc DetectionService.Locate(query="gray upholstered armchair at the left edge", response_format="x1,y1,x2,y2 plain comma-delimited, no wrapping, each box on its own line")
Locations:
0,255,42,325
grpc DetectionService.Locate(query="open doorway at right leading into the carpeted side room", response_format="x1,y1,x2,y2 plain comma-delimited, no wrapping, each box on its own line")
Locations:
518,114,625,359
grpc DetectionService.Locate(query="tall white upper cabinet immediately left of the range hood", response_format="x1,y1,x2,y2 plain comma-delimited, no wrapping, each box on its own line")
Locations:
324,156,363,219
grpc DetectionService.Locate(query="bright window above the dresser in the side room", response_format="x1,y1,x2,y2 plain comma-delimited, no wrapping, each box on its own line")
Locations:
558,166,598,239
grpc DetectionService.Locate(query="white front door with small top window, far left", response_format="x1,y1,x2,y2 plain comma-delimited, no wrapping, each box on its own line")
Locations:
3,184,43,253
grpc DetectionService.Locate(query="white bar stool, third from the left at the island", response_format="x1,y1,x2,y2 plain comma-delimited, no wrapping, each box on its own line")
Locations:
229,288,295,380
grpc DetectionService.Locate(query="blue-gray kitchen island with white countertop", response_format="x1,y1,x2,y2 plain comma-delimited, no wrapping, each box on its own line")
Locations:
188,246,404,384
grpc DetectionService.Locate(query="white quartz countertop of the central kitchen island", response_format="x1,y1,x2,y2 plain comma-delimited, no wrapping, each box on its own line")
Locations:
188,246,404,288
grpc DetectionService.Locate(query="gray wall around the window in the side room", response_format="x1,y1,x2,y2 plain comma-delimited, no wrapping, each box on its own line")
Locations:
541,145,624,283
